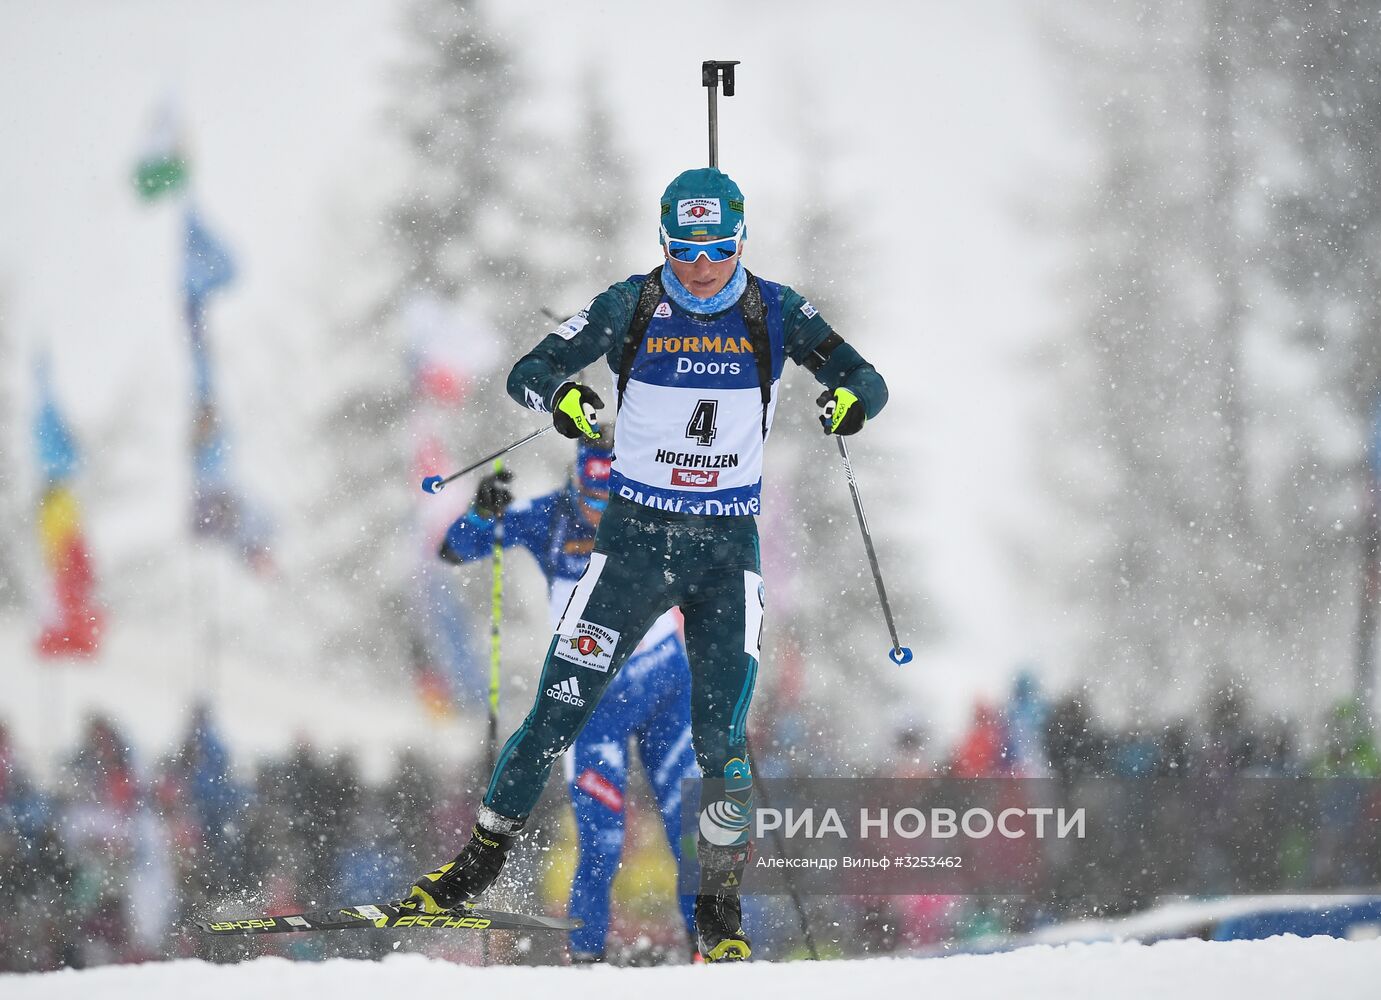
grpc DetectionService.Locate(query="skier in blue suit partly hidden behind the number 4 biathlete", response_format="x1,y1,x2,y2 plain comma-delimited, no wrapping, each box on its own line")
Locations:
441,431,700,963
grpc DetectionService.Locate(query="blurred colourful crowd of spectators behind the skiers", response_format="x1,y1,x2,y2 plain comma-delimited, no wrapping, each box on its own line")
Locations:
0,671,1381,971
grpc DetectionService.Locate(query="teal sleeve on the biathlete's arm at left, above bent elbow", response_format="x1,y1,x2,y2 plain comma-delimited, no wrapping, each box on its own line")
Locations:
508,280,639,413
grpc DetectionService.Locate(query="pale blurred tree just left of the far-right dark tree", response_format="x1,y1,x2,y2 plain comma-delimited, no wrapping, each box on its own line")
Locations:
1045,6,1254,729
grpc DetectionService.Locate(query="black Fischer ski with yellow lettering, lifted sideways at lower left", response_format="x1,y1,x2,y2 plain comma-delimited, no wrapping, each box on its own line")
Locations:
193,903,581,935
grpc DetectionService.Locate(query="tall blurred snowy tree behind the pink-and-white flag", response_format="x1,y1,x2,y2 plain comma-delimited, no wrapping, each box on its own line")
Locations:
302,0,544,679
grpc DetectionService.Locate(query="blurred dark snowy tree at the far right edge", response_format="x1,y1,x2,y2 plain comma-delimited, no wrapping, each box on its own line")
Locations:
1258,3,1381,712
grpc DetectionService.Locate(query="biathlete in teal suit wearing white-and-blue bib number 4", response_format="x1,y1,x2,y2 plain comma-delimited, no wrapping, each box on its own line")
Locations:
405,167,887,961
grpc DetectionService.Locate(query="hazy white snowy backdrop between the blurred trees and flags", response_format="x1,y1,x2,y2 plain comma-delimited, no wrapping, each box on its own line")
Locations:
0,1,1081,773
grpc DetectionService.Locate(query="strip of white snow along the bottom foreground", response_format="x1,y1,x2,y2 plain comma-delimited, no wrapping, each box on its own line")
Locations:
0,936,1381,1000
